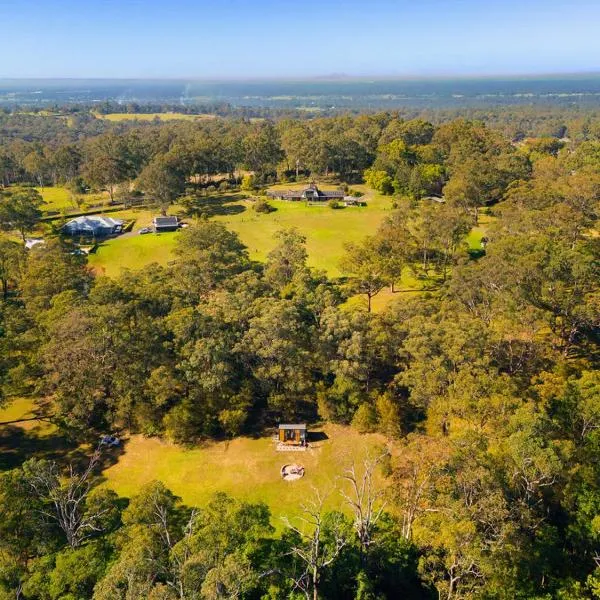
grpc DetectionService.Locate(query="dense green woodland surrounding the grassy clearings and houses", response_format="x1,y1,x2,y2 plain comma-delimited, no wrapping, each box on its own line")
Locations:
0,106,600,600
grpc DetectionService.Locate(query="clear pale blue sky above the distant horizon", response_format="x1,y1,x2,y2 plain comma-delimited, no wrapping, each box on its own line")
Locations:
0,0,600,79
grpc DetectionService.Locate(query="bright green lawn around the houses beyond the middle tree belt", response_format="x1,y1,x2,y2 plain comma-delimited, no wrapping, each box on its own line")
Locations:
82,184,493,310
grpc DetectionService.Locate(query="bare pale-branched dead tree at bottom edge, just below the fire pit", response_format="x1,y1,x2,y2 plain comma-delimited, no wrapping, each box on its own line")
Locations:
283,490,348,600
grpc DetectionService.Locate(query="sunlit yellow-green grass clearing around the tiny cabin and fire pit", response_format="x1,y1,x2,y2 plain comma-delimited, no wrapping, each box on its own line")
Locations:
103,424,384,523
